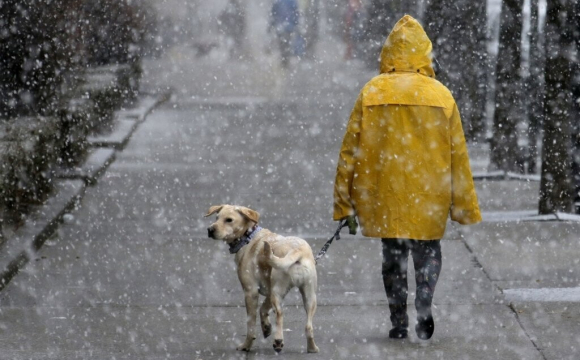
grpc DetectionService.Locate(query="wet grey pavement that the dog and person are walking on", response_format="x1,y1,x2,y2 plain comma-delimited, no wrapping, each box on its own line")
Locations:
0,40,580,360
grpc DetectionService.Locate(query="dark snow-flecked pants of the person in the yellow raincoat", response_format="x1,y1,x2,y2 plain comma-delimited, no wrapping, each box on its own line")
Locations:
382,239,441,328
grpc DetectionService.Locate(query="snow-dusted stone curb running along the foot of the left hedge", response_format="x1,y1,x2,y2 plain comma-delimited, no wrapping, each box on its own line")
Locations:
0,92,171,291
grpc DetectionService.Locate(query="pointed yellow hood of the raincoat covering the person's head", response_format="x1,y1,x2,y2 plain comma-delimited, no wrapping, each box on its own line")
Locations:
380,15,435,78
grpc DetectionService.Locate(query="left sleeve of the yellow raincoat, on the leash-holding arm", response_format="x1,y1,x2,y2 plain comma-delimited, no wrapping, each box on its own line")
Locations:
333,92,363,221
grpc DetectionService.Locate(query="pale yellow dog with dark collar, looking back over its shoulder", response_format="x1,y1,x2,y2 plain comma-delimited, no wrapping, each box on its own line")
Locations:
205,205,319,353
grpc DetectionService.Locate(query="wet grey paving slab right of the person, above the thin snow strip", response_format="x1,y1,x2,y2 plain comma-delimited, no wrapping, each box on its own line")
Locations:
461,222,580,288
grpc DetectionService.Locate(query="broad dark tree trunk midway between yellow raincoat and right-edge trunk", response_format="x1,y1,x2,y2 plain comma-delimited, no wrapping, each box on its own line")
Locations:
490,0,523,172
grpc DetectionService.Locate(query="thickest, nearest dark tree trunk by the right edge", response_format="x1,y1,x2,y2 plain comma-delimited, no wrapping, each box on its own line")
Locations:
539,0,574,214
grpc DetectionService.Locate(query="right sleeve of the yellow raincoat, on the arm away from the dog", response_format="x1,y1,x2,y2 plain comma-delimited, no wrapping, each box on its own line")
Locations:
450,105,481,225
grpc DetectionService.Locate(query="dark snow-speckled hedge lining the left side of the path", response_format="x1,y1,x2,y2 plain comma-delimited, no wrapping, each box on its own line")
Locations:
0,0,155,229
